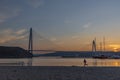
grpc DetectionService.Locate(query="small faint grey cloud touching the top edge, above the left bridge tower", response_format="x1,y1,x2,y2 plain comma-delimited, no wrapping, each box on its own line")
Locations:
27,0,44,8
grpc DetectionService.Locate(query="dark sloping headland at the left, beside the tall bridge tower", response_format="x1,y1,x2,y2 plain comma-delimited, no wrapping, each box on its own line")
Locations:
0,46,33,58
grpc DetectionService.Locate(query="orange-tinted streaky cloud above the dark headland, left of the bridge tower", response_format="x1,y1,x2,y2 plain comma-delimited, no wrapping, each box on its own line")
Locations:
0,29,27,44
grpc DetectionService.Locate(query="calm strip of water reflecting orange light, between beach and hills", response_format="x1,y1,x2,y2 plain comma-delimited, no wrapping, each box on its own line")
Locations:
0,57,120,67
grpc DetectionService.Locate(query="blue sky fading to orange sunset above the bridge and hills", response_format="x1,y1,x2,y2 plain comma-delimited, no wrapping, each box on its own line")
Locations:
0,0,120,51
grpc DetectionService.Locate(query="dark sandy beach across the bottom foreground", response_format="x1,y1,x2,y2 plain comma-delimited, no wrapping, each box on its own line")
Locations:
0,66,120,80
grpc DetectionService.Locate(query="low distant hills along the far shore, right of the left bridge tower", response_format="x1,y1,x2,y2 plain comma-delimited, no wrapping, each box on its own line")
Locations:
35,51,120,58
